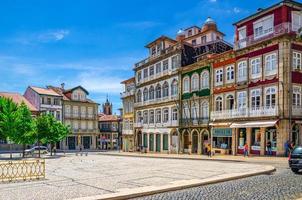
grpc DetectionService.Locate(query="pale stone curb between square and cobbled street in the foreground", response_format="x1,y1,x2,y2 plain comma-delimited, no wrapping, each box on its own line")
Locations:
73,166,276,200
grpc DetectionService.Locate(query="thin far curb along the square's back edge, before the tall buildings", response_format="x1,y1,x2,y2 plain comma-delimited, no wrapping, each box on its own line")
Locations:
97,153,245,162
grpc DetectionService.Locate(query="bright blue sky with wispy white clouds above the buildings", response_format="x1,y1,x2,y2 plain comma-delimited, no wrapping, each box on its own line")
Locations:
0,0,290,113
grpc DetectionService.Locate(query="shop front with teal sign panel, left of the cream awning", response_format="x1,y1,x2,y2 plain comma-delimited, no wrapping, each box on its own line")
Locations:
212,128,232,155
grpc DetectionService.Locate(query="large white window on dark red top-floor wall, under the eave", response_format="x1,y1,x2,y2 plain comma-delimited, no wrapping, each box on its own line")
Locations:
254,15,274,39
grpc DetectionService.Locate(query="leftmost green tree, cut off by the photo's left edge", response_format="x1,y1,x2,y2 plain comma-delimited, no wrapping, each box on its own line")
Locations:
0,98,18,159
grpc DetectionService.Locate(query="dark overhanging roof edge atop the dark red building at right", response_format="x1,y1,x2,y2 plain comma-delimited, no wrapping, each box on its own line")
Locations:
233,0,302,26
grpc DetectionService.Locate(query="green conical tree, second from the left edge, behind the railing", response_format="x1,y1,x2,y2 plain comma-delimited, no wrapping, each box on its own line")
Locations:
12,102,36,157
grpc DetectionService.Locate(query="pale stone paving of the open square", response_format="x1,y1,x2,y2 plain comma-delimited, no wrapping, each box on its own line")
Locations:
0,153,268,200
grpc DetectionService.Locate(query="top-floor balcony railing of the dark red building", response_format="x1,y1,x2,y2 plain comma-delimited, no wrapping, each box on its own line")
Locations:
234,22,296,50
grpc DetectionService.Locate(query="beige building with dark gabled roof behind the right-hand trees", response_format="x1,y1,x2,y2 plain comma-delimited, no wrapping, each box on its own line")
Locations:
48,85,100,150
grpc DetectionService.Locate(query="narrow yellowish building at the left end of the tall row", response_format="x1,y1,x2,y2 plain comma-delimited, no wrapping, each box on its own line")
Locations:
121,77,135,152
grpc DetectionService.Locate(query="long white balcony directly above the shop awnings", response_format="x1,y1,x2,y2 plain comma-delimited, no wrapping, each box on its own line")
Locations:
211,107,278,120
